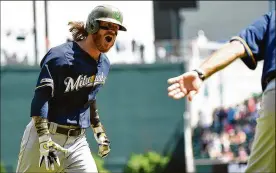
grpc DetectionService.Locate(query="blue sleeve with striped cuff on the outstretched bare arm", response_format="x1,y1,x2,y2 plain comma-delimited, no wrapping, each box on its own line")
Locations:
230,13,270,69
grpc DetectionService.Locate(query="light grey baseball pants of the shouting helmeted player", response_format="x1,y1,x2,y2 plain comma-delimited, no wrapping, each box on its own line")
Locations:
16,121,98,173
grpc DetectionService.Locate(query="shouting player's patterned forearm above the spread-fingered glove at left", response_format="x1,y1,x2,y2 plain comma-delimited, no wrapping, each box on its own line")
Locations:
32,116,49,137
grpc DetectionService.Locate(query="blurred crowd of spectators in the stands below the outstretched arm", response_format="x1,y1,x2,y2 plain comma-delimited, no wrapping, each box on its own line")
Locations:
193,96,260,163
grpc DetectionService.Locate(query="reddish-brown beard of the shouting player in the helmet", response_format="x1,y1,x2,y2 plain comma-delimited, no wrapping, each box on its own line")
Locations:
92,32,115,53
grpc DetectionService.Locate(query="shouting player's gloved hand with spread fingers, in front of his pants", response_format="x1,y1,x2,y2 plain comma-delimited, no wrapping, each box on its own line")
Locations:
39,135,68,170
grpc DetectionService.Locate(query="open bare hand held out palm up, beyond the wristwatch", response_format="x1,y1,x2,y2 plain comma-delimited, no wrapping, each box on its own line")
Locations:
168,71,203,101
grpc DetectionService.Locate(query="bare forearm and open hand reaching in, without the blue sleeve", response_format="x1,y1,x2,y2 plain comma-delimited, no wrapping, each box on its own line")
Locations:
168,41,246,101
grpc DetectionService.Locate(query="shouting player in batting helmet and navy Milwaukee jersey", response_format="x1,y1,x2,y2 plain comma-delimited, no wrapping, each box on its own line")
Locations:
16,5,126,173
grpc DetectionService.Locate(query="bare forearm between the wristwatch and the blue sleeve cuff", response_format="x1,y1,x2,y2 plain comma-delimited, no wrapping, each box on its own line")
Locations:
200,41,246,78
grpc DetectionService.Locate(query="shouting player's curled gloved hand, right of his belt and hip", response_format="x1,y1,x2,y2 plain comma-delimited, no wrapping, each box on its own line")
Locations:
94,132,111,158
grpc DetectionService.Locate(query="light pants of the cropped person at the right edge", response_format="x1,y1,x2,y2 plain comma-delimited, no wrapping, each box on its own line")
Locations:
245,79,276,173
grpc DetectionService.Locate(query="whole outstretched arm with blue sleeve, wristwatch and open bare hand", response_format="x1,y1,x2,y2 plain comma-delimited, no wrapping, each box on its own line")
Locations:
168,13,270,101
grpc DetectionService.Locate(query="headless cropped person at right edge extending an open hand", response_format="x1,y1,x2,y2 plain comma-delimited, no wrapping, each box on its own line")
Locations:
168,10,276,173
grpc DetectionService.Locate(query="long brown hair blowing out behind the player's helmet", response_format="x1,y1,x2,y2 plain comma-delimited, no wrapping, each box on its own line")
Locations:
68,21,88,41
